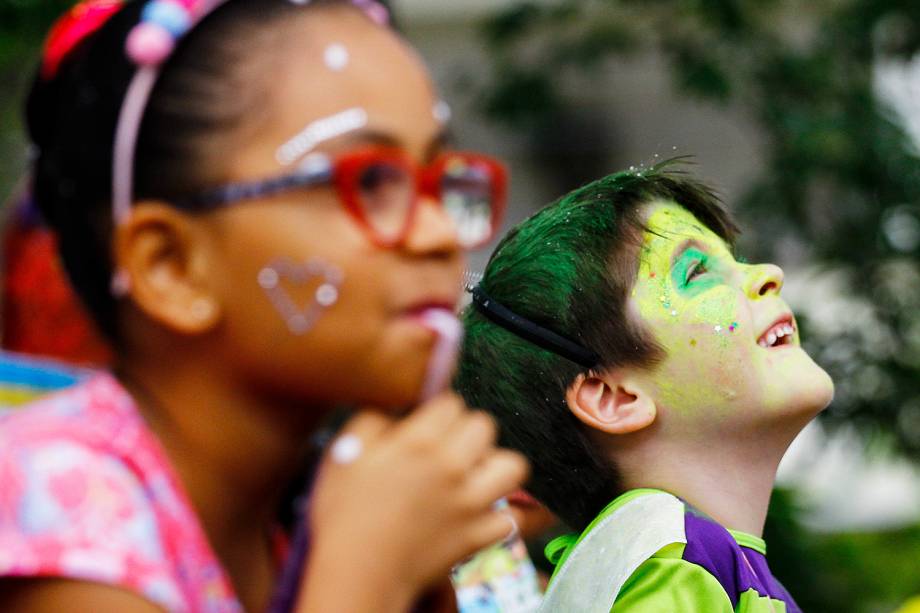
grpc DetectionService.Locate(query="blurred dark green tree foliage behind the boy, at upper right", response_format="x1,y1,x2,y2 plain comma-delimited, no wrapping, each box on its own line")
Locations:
482,0,920,459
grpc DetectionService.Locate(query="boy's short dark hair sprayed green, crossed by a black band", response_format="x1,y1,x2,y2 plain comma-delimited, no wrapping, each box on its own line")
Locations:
456,163,736,528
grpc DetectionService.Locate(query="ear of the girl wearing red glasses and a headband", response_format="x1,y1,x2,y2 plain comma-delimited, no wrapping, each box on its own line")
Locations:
114,202,221,335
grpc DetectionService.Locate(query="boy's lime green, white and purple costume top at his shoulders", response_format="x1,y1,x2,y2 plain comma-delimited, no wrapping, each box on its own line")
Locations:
541,490,801,613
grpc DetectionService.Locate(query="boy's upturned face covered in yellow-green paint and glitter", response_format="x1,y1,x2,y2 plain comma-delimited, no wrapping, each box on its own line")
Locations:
631,203,833,430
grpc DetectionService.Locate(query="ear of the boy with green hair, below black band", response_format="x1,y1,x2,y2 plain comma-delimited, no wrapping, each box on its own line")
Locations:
565,370,658,434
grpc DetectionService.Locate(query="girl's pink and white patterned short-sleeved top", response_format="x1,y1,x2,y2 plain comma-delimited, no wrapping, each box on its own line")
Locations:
0,375,242,613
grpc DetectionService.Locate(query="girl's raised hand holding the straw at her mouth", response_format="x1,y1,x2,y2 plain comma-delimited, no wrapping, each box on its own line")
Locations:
300,393,528,612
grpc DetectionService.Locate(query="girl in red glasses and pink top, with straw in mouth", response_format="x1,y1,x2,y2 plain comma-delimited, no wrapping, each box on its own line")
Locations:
0,0,526,613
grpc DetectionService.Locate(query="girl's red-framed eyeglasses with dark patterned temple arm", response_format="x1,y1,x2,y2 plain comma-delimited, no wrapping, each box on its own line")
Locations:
181,148,508,249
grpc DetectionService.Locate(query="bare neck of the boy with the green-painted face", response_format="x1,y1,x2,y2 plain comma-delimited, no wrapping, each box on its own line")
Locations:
616,422,807,537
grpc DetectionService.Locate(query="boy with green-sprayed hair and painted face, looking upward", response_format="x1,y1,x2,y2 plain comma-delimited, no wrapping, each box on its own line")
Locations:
457,166,833,613
